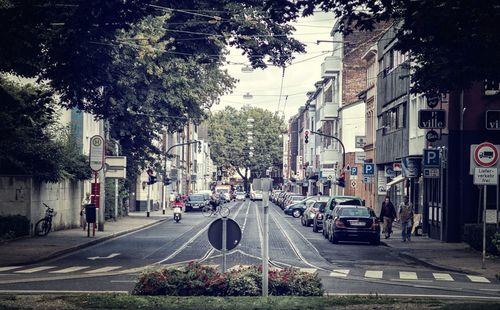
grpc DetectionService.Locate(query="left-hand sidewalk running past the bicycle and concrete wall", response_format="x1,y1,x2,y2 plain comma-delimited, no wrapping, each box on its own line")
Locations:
0,210,172,266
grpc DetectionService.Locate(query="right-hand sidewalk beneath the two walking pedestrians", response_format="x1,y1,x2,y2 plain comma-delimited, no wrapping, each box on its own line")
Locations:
381,223,500,278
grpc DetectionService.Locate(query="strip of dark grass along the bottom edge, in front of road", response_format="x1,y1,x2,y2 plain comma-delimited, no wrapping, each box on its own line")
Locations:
0,294,500,310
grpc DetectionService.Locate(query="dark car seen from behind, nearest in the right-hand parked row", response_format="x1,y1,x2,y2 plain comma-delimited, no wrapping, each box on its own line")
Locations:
328,205,380,245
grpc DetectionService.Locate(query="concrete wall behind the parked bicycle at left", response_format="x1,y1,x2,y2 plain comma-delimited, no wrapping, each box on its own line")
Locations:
0,176,83,231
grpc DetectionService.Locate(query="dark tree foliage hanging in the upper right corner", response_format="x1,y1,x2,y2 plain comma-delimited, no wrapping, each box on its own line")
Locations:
292,0,500,93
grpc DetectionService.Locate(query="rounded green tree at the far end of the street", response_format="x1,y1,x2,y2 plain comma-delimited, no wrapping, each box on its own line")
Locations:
208,107,286,189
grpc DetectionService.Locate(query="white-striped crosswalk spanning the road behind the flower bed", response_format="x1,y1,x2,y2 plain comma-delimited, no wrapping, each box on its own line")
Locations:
0,265,492,283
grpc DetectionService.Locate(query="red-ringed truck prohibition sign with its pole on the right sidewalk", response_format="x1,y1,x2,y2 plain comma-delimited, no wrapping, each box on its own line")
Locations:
474,142,498,269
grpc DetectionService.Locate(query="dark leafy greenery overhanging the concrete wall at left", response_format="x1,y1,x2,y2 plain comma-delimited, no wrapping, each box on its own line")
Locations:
0,77,91,182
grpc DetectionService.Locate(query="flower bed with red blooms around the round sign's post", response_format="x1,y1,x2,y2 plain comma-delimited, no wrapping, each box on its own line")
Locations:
133,263,323,296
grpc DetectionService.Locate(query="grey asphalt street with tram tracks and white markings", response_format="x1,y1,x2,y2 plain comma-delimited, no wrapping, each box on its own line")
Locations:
0,200,500,299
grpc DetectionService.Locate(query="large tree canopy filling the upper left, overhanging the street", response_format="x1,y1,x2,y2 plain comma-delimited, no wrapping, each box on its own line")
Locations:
0,0,304,177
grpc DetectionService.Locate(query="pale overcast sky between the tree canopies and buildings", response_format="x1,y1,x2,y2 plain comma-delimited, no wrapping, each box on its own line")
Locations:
212,13,334,121
